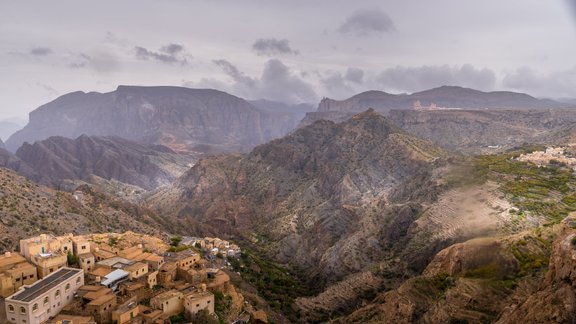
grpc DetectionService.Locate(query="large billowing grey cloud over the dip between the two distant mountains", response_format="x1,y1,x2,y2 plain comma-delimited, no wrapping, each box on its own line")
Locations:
207,59,318,103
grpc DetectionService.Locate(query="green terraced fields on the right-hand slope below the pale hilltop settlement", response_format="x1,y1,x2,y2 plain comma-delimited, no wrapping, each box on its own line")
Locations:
473,148,576,225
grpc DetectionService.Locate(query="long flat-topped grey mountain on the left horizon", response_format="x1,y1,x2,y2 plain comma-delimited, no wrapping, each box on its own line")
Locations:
6,86,304,153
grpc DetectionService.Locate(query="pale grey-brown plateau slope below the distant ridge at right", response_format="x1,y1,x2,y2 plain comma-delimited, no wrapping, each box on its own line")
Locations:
388,109,576,154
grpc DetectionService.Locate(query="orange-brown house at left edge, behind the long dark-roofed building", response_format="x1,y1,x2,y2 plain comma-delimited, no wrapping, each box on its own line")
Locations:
0,252,38,297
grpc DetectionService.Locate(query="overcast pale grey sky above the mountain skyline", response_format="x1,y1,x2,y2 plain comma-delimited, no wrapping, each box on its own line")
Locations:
0,0,576,120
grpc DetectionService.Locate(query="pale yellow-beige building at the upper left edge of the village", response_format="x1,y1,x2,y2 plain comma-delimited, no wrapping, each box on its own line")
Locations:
20,234,73,261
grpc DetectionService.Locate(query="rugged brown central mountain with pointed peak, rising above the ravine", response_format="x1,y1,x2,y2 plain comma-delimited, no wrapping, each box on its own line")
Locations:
148,110,444,281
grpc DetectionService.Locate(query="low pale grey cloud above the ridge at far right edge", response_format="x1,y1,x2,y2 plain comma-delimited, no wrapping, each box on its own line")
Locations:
502,66,576,98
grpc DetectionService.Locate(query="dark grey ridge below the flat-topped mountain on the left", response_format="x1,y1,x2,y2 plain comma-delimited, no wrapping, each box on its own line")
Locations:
10,135,191,190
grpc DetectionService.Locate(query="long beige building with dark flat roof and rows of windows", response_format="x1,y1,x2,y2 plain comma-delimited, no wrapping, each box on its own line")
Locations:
5,268,84,324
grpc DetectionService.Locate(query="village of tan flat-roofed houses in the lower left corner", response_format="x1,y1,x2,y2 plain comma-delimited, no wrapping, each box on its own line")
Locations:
0,234,234,324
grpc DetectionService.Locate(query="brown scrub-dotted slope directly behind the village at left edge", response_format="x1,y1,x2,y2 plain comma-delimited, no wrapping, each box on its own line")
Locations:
0,168,166,252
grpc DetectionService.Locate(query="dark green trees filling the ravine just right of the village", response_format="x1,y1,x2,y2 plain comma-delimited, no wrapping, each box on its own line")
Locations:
228,250,312,322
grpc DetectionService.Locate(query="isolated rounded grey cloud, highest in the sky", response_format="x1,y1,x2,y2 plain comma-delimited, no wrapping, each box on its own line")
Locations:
338,9,396,36
